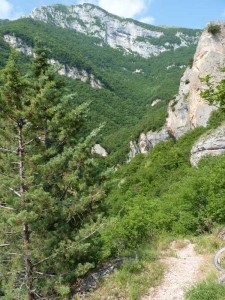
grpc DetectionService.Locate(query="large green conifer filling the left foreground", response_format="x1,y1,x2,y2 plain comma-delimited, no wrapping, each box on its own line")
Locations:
0,49,104,300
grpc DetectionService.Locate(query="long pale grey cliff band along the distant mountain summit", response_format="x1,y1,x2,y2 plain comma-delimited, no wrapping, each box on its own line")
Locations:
30,3,199,58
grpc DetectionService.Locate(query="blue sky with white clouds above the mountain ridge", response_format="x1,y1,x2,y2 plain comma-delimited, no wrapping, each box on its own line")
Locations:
0,0,225,28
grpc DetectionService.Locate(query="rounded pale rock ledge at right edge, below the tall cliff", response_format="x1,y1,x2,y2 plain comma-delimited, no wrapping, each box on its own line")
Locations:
190,125,225,166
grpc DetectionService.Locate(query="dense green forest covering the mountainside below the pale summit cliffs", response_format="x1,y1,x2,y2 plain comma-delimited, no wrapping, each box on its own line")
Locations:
0,12,199,163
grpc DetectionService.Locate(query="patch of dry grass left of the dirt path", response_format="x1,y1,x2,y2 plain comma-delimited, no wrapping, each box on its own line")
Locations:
86,245,164,300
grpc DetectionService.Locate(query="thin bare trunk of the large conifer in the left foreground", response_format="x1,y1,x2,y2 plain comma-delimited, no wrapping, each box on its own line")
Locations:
17,118,34,300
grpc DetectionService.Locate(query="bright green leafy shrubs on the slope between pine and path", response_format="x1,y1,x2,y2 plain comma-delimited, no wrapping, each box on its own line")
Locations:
101,111,225,253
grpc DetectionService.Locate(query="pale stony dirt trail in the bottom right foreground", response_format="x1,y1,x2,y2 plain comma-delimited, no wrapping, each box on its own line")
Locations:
142,241,204,300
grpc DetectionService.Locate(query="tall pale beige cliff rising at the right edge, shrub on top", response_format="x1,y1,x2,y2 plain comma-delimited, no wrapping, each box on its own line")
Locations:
167,23,225,138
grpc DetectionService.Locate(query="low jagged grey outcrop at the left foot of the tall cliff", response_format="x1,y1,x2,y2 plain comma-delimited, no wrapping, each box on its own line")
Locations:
128,127,169,162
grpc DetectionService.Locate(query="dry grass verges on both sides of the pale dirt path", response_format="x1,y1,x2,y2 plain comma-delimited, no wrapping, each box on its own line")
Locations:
85,228,225,300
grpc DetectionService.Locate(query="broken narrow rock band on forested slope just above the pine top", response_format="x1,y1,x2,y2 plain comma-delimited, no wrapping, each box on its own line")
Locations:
4,35,103,89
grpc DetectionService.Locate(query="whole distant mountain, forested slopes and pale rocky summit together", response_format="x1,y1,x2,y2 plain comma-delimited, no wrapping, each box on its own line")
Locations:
0,5,200,163
